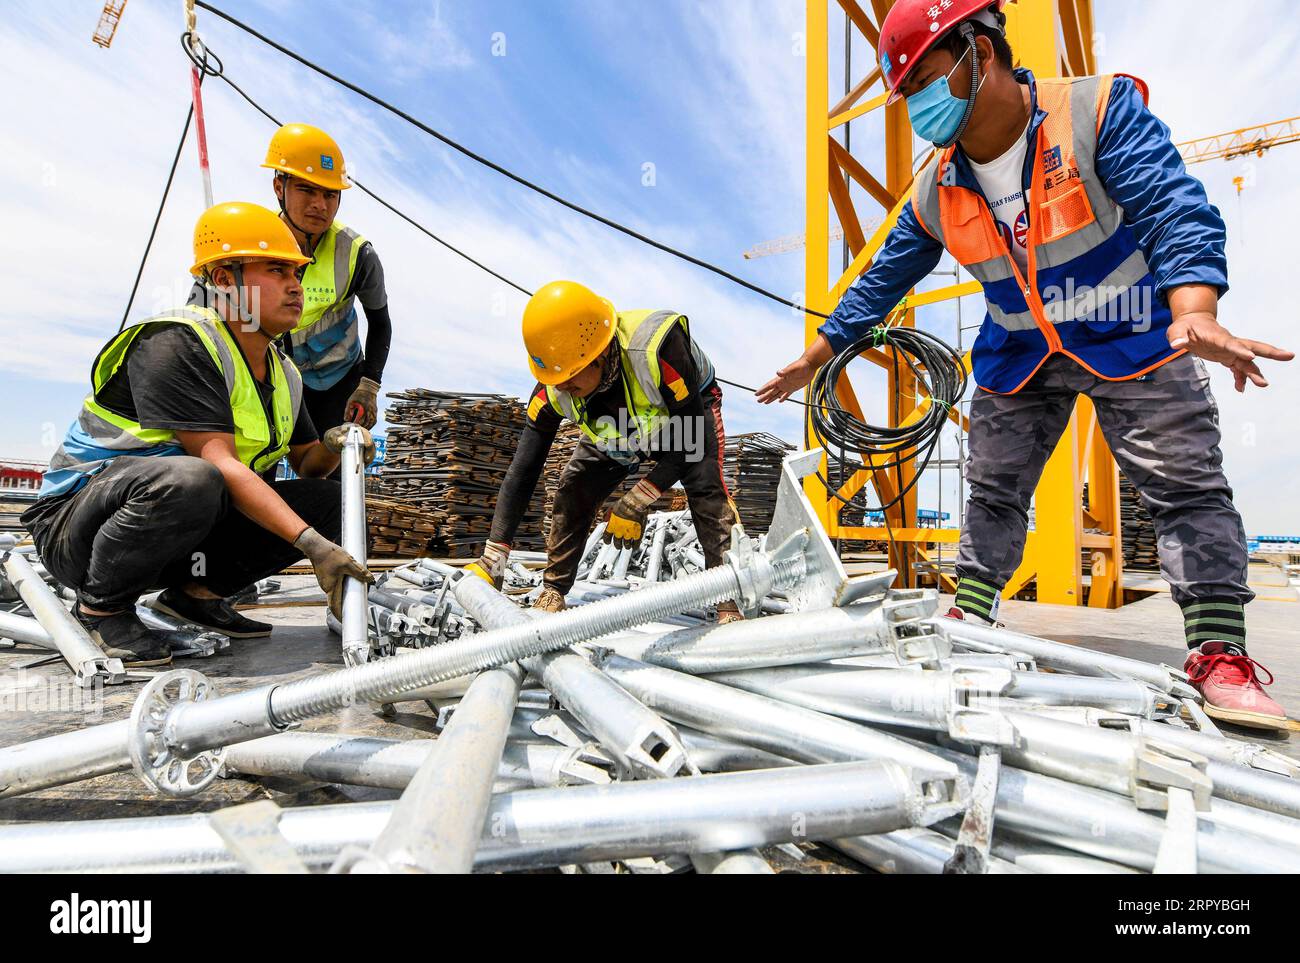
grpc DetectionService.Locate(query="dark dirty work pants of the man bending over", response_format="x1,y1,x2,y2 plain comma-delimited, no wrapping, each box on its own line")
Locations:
542,385,740,595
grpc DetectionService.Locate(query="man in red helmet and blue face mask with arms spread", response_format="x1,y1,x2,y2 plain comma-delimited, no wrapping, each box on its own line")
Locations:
758,0,1294,728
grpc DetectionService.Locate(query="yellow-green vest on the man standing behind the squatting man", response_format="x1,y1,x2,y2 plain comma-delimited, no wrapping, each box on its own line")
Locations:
289,221,365,390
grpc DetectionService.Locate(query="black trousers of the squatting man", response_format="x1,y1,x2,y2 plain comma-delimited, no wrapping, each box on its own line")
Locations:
29,455,342,611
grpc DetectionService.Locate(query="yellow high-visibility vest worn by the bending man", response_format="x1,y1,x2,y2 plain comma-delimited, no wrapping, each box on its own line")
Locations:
546,311,714,464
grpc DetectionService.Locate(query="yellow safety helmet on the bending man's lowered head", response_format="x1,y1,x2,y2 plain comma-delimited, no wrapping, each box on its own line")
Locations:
524,281,618,385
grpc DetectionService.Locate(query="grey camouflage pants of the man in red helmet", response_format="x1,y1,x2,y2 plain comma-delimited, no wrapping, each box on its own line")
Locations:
957,355,1255,604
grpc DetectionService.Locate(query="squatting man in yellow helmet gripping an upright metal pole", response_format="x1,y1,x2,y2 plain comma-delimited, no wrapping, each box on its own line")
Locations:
22,203,374,665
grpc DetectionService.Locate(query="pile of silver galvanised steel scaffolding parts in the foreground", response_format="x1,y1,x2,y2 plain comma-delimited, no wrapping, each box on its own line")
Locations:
0,451,1300,873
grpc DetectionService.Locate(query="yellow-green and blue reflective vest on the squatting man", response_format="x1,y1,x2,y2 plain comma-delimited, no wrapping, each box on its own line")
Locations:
40,307,303,498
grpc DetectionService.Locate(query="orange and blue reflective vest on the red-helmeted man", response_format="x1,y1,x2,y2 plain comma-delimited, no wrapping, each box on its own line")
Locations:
913,74,1183,394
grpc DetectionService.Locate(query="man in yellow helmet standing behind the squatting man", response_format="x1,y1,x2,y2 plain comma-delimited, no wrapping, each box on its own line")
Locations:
261,123,393,433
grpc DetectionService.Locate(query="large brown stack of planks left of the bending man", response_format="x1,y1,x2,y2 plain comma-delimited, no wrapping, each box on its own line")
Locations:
369,389,545,558
